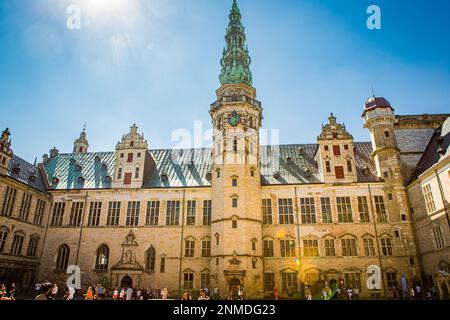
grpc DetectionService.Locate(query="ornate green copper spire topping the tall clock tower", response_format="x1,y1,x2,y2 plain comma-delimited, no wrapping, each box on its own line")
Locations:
219,0,252,86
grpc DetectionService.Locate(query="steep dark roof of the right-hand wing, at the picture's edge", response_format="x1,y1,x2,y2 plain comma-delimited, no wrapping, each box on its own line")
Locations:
409,117,450,183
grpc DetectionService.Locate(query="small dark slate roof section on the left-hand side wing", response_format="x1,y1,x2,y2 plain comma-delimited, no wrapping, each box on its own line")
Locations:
7,155,47,192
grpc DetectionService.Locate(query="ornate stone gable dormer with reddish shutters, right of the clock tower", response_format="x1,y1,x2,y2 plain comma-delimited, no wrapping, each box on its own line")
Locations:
315,114,357,183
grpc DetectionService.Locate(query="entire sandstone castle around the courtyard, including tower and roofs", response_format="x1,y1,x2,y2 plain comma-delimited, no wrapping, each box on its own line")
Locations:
0,1,450,298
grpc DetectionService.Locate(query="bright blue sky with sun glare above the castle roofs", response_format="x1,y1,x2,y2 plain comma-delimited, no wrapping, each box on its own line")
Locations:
0,0,450,161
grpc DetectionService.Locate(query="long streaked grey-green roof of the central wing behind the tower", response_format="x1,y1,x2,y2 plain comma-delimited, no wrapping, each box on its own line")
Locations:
45,142,380,190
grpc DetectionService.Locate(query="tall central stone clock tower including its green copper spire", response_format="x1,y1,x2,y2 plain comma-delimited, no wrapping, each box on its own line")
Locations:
210,0,263,297
